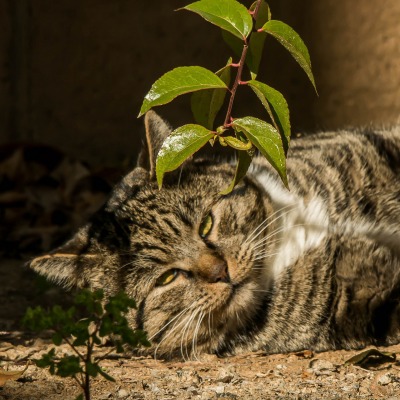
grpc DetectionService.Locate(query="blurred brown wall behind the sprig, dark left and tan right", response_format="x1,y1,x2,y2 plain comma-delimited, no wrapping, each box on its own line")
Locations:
0,0,400,166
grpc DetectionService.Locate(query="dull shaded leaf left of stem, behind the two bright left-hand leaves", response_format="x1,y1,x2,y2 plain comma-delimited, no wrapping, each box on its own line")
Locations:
191,58,232,129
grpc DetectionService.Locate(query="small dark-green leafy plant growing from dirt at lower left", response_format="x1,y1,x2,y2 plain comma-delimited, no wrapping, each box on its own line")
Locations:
22,290,150,400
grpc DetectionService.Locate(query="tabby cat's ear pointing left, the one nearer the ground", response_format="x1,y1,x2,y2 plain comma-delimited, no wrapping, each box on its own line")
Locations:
28,225,98,288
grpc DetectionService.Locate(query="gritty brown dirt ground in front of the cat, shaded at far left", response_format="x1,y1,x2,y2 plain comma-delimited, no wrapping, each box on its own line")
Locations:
0,259,400,400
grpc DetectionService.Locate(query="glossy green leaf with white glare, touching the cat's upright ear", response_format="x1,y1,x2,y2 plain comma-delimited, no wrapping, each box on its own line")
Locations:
156,124,214,188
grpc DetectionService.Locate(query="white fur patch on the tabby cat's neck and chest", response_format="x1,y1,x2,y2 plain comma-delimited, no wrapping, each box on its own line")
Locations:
251,161,400,286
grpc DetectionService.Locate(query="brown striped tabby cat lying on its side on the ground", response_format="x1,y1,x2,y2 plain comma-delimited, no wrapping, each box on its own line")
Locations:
30,111,400,358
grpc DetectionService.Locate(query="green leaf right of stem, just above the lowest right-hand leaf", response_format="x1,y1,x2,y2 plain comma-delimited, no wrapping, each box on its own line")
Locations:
247,80,291,154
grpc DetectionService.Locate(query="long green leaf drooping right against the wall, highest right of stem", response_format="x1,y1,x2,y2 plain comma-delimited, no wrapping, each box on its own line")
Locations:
261,20,317,91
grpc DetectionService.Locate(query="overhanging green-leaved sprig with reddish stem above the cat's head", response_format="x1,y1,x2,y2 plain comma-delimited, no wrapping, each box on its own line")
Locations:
139,0,315,193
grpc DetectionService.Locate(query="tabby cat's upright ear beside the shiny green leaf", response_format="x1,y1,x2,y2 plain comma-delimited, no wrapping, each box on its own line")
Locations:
138,110,172,179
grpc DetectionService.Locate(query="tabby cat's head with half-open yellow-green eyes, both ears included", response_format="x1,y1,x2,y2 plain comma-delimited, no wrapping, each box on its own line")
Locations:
30,112,276,356
